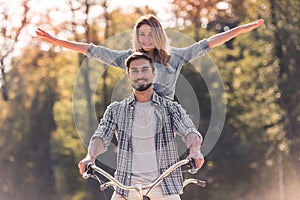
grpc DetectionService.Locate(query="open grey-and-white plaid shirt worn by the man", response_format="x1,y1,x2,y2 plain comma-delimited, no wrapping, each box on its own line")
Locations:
91,92,202,197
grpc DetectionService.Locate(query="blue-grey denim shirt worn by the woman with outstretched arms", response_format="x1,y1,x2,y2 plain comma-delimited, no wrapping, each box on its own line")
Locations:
86,39,210,99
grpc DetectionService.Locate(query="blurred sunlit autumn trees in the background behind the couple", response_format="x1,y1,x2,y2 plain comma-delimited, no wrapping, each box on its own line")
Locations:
0,0,300,200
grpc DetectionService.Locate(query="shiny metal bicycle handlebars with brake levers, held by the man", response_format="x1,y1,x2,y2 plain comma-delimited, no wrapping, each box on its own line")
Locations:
82,159,206,200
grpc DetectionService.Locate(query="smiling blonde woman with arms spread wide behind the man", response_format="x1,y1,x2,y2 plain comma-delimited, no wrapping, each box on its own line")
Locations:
36,15,264,99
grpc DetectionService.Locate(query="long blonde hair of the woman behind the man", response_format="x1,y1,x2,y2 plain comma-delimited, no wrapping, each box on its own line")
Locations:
133,15,170,65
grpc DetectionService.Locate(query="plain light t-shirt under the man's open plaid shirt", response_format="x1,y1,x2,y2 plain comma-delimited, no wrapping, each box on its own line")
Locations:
132,101,159,184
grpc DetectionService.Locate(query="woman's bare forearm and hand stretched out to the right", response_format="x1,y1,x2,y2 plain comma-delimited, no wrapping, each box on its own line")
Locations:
207,19,264,48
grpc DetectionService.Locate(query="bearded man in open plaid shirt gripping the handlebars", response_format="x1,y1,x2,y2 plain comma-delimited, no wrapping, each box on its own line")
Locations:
78,53,204,200
